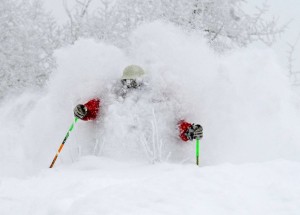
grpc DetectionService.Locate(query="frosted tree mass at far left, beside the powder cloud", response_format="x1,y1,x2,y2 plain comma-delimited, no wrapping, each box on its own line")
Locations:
0,0,59,97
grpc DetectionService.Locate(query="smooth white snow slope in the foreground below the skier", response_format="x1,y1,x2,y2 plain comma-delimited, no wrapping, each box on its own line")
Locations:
0,156,300,215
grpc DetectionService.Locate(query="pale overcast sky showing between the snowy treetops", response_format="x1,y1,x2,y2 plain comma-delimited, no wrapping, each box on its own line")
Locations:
43,0,300,70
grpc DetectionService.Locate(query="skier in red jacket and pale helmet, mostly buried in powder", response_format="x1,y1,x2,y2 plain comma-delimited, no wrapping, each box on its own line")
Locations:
74,65,203,142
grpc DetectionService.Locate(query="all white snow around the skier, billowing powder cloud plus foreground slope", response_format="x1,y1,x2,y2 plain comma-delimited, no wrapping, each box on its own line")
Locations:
0,22,300,215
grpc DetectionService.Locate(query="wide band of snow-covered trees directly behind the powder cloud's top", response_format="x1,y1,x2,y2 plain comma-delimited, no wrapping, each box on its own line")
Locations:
62,0,284,50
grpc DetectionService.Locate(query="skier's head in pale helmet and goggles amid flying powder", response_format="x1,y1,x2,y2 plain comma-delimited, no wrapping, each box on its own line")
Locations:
121,65,145,88
